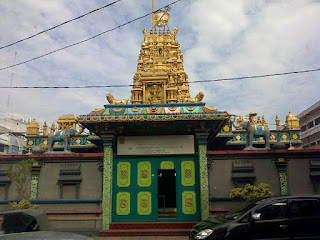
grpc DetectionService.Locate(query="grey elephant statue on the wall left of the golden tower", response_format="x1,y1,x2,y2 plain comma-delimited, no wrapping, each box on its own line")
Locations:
47,128,78,153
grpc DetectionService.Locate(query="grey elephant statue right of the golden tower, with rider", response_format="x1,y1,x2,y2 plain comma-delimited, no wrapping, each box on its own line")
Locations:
230,112,270,150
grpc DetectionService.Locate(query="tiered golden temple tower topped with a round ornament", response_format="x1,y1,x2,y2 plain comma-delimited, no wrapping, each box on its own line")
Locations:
130,10,204,104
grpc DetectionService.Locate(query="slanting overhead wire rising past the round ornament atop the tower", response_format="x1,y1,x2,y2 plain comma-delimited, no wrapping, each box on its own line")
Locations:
0,0,182,71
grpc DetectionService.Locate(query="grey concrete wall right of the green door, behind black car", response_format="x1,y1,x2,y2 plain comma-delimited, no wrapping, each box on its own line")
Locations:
208,150,320,212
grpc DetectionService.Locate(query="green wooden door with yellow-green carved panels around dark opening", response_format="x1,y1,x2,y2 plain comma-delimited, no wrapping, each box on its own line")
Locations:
112,156,200,222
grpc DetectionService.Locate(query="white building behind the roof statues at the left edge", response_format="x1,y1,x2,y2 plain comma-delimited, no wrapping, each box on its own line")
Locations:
0,118,28,155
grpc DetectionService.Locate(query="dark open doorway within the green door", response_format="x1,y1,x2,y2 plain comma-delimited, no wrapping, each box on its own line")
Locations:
158,169,177,218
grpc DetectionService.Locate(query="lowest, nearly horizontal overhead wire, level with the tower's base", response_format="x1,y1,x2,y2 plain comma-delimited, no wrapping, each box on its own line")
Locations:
0,68,320,89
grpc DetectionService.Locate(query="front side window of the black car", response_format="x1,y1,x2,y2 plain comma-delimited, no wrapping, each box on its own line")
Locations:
255,202,287,220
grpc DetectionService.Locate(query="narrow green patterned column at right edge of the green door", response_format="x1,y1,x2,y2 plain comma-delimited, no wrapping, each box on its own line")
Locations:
197,135,209,220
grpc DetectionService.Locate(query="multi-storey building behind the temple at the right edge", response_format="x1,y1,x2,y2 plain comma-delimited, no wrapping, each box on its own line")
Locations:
297,101,320,148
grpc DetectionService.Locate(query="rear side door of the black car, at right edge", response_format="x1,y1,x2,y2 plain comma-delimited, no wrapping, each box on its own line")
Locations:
289,198,320,239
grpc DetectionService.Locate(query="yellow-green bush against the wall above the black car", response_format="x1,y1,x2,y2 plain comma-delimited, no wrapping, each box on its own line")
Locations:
230,183,273,201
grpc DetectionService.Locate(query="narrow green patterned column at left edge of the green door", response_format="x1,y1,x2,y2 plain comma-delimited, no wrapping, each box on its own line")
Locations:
102,137,113,230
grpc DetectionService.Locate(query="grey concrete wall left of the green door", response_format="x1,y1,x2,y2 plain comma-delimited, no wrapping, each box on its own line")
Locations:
0,156,102,235
